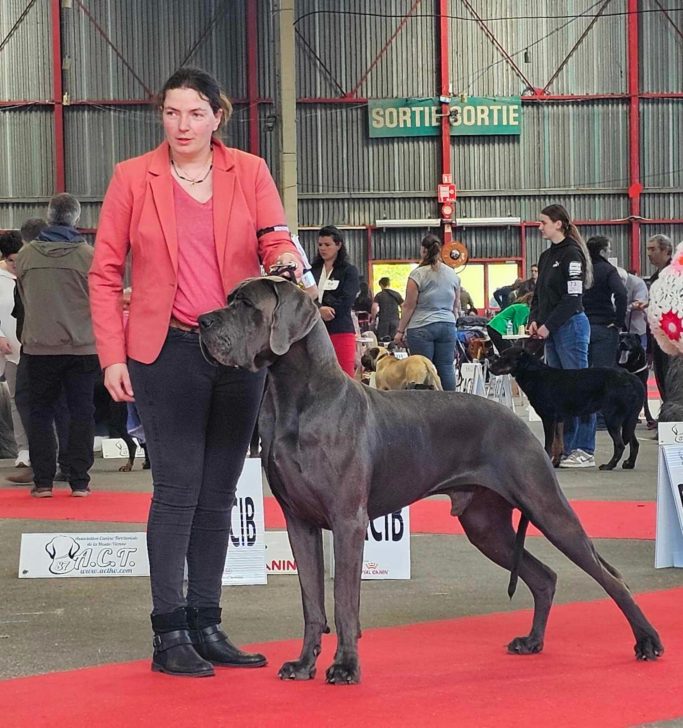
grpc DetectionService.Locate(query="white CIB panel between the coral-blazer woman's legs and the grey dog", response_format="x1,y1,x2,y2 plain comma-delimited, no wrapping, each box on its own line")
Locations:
222,458,267,586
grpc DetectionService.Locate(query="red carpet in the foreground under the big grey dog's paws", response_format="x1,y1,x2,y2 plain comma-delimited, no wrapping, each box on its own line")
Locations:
0,589,683,728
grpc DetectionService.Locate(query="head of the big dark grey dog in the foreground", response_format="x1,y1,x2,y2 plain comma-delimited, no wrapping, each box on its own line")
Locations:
199,276,321,372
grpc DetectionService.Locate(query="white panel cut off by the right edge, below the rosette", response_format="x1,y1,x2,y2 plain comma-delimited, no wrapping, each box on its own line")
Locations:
655,422,683,569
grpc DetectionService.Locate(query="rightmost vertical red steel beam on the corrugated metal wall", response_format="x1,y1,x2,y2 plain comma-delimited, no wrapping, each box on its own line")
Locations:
626,0,643,273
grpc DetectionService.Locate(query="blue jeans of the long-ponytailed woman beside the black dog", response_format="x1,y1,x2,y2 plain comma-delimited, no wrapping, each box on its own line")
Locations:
545,313,595,455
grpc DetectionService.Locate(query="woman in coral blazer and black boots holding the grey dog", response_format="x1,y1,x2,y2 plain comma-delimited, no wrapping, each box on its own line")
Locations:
90,68,301,677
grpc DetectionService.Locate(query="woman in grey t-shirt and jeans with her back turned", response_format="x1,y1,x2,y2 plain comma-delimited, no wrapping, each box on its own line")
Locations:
394,234,460,390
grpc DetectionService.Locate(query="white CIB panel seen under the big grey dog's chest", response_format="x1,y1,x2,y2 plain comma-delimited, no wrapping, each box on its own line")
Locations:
330,507,410,580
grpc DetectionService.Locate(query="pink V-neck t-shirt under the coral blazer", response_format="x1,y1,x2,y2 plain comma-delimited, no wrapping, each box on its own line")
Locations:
172,180,225,326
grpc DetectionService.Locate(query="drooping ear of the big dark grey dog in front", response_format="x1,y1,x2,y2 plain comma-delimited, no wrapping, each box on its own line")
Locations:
261,276,320,356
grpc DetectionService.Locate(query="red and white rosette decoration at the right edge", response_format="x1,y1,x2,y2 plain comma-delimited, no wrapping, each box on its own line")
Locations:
647,243,683,355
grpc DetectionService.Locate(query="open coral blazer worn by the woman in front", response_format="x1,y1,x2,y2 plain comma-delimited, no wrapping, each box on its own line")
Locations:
89,141,299,368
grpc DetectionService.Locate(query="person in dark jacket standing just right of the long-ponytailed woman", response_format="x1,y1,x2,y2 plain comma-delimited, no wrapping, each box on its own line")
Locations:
583,235,628,367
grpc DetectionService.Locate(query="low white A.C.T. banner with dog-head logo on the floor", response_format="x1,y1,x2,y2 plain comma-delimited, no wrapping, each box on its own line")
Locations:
19,532,149,579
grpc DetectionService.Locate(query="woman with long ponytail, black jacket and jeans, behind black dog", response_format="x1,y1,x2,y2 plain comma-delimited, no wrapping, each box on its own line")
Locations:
529,205,595,468
